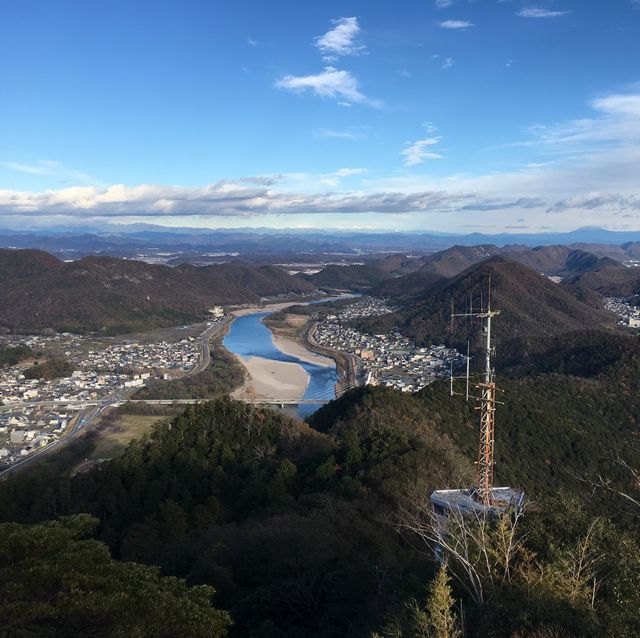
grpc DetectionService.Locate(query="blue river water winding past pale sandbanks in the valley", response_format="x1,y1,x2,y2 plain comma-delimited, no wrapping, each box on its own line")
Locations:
222,312,338,418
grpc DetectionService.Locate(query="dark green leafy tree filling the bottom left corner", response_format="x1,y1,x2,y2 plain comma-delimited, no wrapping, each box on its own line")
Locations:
0,514,231,638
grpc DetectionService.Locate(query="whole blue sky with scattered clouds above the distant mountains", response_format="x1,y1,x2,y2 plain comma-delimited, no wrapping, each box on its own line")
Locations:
0,0,640,233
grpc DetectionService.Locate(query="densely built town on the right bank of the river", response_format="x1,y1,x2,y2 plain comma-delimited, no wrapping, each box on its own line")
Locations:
313,297,465,392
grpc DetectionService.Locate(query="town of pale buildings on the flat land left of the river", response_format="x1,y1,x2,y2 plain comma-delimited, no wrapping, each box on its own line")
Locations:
0,314,222,466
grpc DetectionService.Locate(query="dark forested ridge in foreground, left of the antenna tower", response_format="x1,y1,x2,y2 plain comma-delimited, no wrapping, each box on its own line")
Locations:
0,394,471,638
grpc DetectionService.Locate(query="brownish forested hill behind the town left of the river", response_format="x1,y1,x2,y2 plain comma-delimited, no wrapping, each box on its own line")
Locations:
0,250,314,332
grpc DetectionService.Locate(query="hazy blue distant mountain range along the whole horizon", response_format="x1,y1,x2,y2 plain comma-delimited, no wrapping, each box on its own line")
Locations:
0,224,640,261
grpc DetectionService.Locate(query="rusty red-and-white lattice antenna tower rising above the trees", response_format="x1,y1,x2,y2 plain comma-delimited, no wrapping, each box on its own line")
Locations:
451,277,500,506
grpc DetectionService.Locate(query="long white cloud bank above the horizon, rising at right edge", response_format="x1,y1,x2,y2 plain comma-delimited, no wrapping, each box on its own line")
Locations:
5,89,640,230
